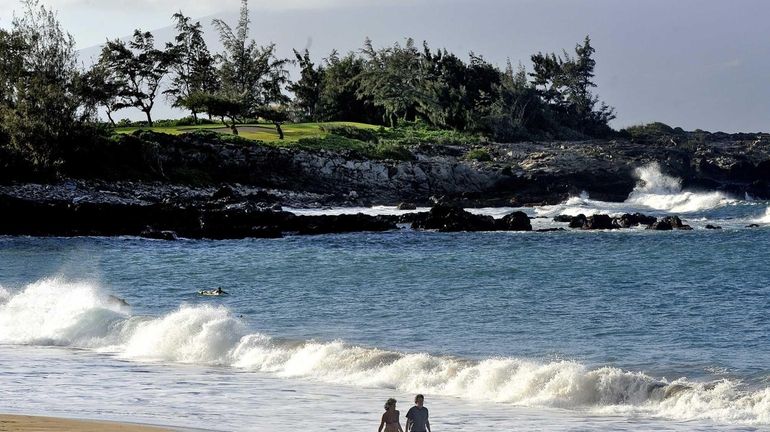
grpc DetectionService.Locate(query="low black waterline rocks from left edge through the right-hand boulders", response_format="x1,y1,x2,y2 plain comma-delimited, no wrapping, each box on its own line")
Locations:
0,185,744,240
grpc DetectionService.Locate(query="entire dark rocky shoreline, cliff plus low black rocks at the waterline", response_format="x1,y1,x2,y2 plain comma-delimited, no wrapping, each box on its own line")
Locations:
0,132,770,239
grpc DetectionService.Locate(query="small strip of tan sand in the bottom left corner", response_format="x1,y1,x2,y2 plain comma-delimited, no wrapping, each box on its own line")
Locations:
0,414,171,432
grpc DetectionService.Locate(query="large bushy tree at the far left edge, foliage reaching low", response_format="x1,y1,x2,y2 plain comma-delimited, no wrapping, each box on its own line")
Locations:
0,0,78,169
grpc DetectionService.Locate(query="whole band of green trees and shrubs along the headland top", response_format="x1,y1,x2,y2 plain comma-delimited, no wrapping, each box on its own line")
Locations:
0,0,616,177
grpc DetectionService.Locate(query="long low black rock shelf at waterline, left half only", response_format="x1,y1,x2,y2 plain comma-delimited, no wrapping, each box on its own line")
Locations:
0,195,396,240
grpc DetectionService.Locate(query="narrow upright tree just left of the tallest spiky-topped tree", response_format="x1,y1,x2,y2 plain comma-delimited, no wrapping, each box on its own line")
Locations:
163,12,219,123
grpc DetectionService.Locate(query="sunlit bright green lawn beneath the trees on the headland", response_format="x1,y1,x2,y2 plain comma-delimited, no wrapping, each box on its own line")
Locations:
115,122,379,142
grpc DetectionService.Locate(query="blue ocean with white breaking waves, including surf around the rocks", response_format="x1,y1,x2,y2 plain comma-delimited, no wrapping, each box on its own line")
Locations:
0,166,770,431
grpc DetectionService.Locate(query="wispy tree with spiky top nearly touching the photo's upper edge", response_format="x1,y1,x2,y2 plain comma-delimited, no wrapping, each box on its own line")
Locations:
213,0,289,133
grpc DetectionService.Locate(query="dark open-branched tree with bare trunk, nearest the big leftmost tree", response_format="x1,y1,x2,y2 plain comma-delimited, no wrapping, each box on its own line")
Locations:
99,29,177,127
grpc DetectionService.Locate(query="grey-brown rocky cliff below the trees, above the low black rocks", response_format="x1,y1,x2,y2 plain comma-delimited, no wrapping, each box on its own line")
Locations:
0,133,770,206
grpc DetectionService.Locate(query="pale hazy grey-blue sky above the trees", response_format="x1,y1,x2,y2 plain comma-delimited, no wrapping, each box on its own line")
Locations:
0,0,770,132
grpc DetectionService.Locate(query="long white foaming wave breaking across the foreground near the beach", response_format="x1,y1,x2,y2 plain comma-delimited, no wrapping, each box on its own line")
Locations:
0,278,770,424
